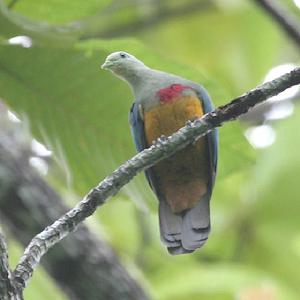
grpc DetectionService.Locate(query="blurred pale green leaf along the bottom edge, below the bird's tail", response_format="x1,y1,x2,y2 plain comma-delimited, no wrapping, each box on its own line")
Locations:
153,262,297,300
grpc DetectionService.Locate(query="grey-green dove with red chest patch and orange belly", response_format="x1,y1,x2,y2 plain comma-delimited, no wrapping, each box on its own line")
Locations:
101,51,218,255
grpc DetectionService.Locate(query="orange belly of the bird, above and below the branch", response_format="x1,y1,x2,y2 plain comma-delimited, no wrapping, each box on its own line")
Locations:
144,96,208,213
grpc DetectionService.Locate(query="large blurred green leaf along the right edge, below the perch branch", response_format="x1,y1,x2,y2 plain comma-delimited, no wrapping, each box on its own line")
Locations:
242,106,300,293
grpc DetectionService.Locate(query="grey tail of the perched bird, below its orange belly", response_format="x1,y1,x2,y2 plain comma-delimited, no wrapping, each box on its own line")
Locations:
159,193,210,255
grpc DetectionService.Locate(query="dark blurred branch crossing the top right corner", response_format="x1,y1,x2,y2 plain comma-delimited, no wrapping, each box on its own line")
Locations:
253,0,300,47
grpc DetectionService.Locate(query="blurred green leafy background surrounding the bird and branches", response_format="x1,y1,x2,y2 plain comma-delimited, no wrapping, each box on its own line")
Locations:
0,0,300,300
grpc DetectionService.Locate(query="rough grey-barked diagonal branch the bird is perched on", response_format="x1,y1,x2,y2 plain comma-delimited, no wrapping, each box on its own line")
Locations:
14,67,300,289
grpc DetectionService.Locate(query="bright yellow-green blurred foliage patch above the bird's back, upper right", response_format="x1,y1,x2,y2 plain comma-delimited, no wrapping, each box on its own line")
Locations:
139,1,286,94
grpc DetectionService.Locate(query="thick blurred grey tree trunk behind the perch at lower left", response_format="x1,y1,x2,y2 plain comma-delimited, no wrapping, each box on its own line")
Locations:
0,115,148,300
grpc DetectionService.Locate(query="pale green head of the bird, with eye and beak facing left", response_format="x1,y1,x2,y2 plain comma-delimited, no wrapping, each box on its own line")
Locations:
101,51,147,80
